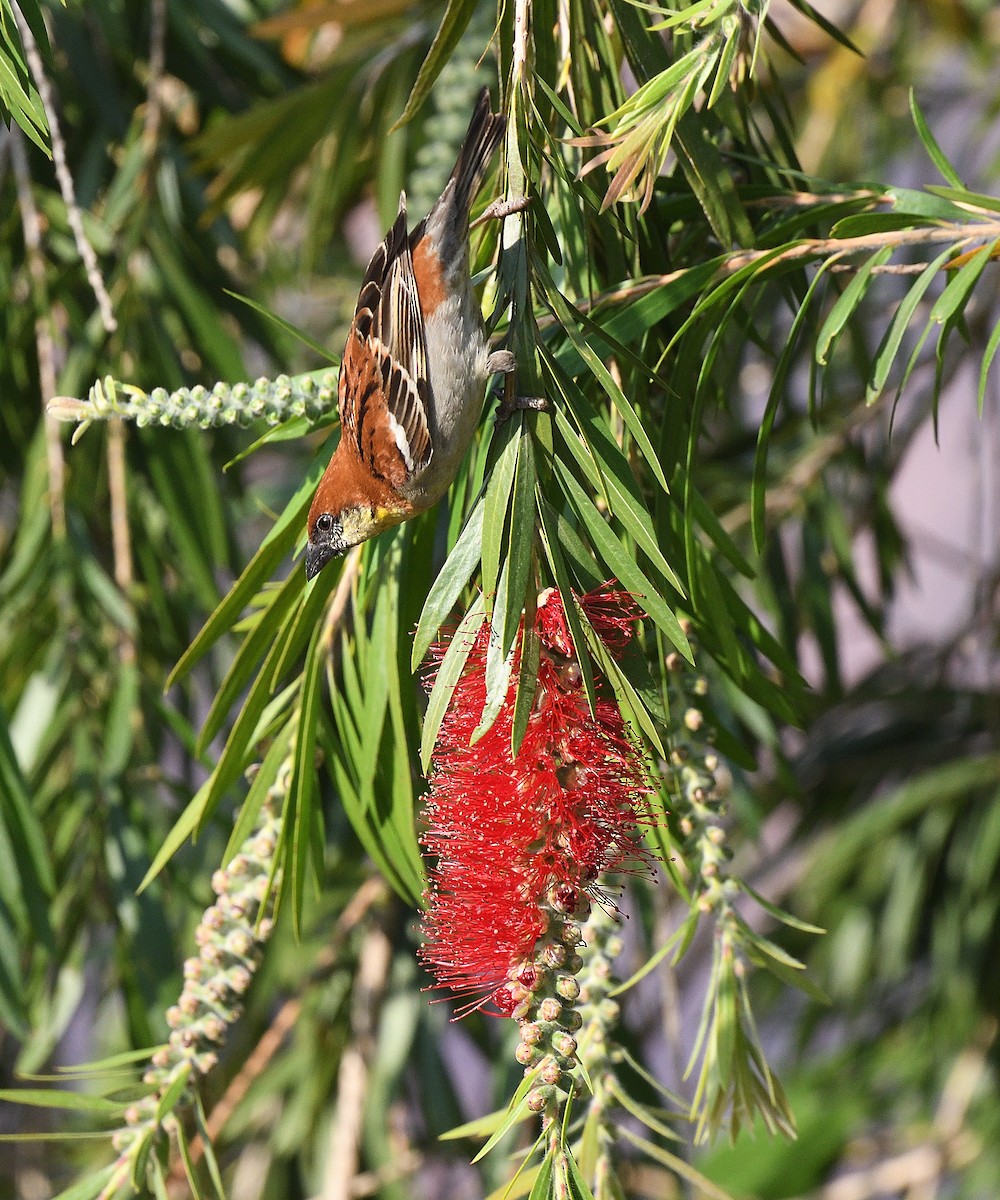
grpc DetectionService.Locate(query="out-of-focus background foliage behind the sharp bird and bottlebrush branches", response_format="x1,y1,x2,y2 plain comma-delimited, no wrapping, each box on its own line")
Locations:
0,0,1000,1200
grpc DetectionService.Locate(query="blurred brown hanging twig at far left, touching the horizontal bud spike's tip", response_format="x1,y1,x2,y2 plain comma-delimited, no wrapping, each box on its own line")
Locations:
9,126,66,541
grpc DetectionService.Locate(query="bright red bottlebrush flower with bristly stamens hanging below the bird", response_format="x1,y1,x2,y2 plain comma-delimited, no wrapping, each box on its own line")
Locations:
421,586,648,1013
